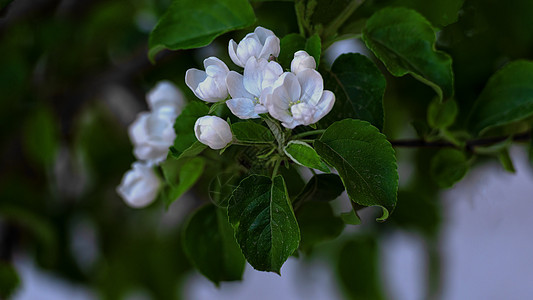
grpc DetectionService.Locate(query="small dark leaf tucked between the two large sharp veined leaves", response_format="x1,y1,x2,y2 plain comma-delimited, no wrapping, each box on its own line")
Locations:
294,174,344,205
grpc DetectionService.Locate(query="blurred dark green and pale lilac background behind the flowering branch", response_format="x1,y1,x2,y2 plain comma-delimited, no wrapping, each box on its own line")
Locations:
0,0,533,299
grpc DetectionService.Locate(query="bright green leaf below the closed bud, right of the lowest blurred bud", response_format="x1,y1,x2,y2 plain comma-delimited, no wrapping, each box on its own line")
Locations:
161,157,205,207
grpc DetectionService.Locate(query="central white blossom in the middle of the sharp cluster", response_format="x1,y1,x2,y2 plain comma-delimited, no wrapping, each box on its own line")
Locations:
226,57,283,119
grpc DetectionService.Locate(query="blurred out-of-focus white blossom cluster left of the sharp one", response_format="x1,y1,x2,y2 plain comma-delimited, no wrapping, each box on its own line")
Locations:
117,81,184,207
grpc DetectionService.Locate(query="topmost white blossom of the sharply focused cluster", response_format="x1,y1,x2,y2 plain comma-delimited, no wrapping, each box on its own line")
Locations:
228,26,280,67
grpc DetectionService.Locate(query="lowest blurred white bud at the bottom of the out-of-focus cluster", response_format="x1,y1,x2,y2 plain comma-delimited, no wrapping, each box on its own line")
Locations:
117,162,161,208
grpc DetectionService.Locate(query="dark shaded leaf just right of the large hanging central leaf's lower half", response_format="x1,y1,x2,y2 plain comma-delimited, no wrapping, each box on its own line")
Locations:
296,202,344,253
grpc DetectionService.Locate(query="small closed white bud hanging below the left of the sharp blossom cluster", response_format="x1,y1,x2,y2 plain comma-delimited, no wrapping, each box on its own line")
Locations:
194,116,233,150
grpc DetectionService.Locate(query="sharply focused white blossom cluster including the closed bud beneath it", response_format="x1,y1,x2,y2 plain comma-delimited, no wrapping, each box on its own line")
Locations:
185,26,335,149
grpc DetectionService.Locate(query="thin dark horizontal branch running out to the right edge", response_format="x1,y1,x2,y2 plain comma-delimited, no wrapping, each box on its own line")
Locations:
390,131,531,151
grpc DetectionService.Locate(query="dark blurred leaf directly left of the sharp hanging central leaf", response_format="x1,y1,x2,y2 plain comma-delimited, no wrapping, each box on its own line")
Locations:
183,205,245,286
